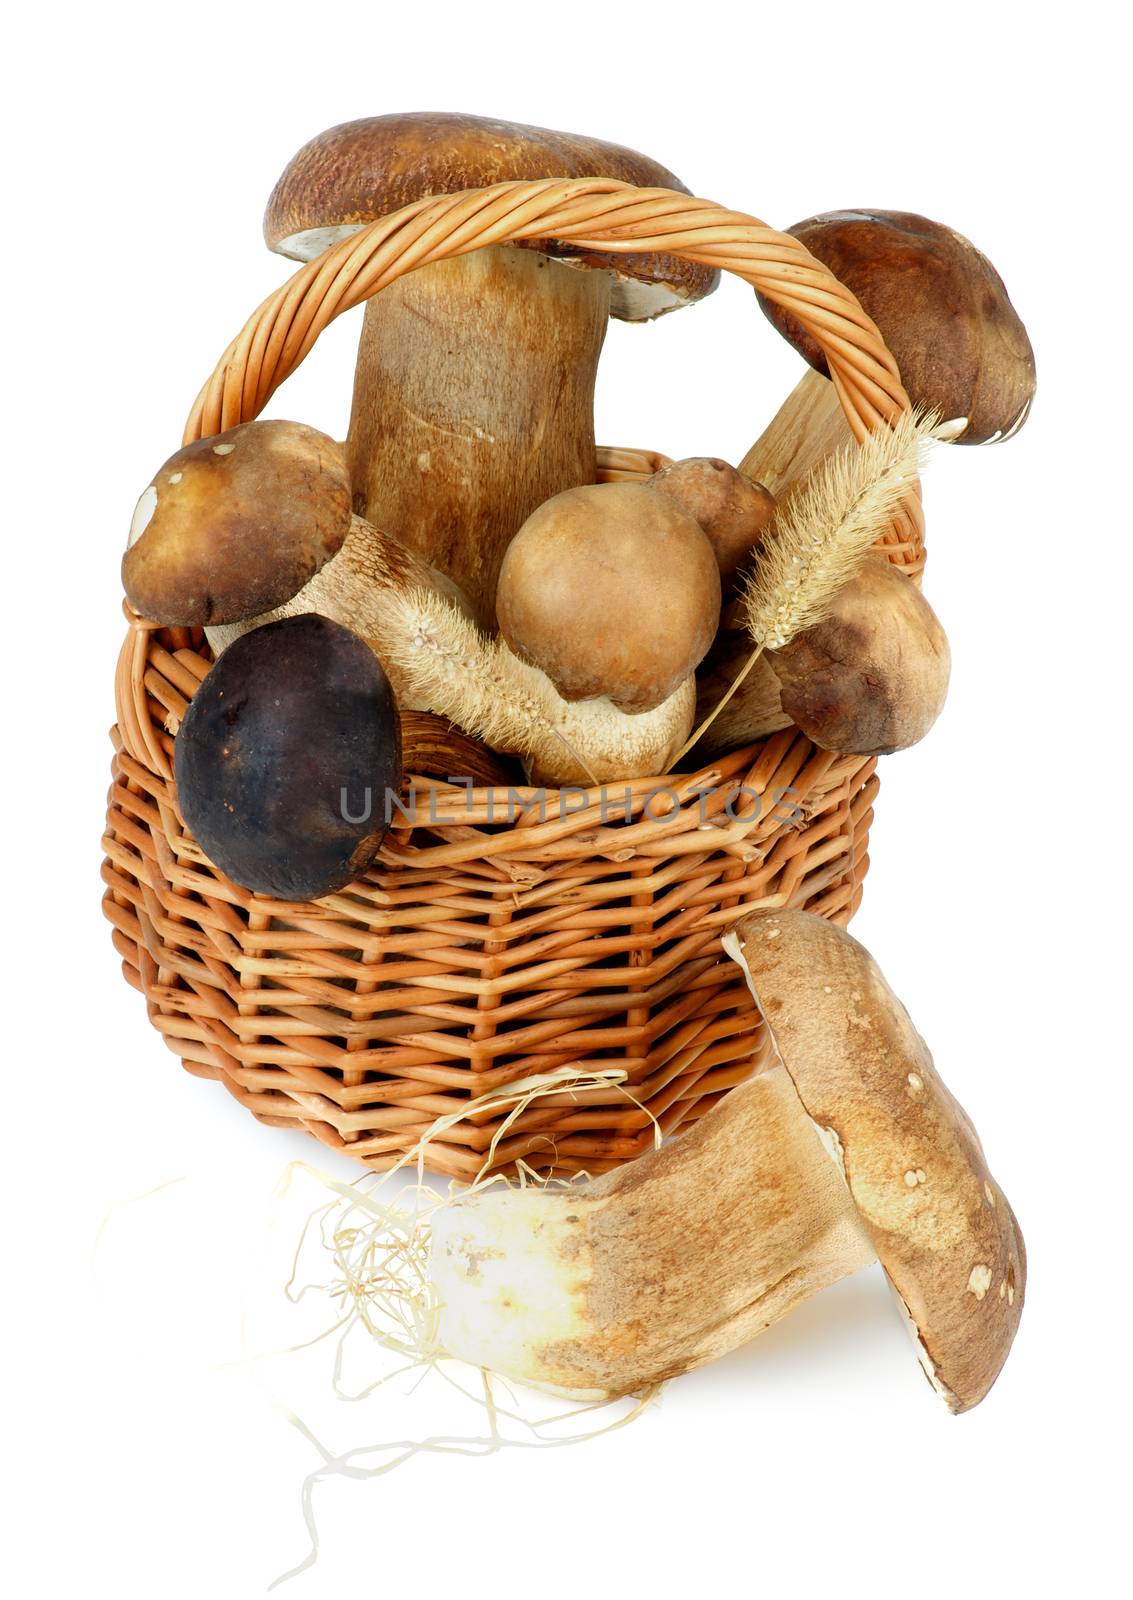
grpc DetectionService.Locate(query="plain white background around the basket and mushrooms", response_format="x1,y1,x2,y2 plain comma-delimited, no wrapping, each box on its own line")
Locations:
0,9,1133,1600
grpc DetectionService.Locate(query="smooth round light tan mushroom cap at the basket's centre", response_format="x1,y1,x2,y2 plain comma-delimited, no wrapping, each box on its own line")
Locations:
496,483,720,712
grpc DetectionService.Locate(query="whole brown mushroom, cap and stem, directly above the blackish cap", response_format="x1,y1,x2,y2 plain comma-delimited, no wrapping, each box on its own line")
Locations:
122,422,470,710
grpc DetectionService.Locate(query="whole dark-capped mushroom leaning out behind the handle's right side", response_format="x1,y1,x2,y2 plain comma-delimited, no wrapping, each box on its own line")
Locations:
741,211,1035,498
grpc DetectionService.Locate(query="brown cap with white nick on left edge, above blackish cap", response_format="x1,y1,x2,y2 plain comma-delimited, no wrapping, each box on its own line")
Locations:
122,422,350,626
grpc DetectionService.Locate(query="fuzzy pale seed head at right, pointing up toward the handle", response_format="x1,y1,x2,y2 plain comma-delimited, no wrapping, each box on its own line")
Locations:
744,411,939,650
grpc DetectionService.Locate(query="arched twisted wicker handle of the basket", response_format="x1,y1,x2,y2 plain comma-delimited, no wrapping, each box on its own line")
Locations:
184,178,923,566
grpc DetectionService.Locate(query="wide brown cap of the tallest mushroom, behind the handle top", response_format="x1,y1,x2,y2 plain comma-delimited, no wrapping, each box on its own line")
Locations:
264,112,720,322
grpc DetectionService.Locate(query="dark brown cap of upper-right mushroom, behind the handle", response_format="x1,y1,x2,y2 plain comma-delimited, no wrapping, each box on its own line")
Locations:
759,211,1035,445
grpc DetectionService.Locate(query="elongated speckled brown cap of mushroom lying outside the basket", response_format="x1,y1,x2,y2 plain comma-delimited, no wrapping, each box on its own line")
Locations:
725,910,1026,1411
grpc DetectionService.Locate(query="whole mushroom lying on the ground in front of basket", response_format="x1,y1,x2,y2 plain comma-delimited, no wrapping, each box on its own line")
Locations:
429,910,1026,1411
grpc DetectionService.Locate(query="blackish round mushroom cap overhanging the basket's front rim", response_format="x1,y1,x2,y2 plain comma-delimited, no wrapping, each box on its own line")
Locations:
174,604,402,901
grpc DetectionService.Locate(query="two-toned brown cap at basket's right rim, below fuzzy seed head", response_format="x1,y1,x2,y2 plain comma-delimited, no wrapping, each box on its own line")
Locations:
768,555,952,755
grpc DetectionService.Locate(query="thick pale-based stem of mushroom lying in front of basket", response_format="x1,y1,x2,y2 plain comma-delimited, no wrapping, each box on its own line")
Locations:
430,1066,875,1398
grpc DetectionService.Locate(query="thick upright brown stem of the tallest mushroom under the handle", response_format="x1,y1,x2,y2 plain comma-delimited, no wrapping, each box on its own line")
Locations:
347,246,611,614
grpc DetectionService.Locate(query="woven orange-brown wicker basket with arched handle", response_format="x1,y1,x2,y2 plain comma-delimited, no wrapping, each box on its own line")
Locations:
104,179,923,1178
